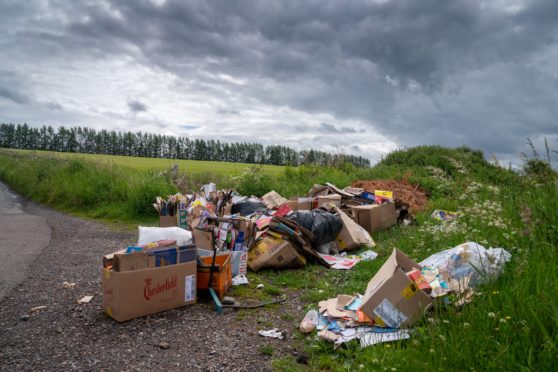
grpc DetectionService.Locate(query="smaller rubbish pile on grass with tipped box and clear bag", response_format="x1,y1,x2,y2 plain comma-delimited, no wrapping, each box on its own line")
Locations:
300,242,511,348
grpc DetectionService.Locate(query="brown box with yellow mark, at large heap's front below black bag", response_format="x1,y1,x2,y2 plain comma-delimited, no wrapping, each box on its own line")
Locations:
248,236,306,271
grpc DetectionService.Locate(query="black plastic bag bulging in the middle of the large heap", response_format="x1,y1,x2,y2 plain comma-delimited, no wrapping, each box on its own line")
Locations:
287,209,343,249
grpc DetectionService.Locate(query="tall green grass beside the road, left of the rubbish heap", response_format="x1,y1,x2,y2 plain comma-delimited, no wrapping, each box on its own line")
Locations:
0,154,176,222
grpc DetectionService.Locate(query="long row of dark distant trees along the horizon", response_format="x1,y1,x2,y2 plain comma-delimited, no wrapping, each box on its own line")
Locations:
0,123,370,167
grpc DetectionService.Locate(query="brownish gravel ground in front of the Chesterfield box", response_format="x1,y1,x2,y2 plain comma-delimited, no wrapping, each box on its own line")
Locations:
0,202,303,371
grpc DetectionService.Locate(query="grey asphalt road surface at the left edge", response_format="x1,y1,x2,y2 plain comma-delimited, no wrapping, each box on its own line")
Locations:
0,182,51,299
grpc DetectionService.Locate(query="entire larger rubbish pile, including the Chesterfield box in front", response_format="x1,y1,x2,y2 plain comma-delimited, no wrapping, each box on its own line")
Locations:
102,183,424,321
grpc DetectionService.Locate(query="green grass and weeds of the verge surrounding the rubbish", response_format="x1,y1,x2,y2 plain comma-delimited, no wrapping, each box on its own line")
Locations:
0,146,558,371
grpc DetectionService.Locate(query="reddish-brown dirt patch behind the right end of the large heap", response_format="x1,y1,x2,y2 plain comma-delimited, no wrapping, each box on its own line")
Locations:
351,180,428,217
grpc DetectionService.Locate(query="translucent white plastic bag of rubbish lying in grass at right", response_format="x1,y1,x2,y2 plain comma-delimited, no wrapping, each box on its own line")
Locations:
420,242,511,286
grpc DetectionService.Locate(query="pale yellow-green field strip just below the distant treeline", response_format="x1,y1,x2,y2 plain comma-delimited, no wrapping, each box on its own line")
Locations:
0,149,285,176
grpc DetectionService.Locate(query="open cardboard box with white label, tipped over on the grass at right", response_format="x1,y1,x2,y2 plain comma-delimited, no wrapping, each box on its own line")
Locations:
361,249,433,328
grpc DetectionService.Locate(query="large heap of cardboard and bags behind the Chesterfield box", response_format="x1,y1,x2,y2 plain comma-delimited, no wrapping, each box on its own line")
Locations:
154,183,410,276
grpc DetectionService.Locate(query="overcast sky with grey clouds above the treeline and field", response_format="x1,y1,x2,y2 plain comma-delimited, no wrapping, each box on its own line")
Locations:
0,0,558,163
